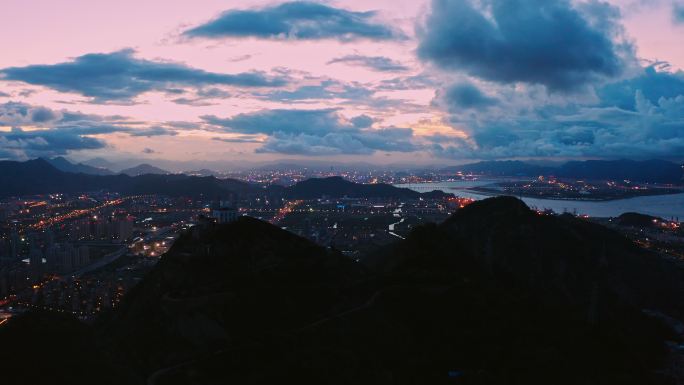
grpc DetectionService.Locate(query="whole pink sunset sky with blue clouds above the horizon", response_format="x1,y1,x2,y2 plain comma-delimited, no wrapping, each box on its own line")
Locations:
0,0,684,168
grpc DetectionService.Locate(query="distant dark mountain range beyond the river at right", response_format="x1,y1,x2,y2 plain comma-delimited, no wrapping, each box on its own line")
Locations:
444,159,684,183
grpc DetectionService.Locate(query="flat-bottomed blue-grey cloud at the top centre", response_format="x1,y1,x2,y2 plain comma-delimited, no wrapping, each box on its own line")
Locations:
183,1,403,41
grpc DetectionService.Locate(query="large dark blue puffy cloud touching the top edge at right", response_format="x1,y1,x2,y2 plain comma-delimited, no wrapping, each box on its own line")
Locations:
418,0,631,91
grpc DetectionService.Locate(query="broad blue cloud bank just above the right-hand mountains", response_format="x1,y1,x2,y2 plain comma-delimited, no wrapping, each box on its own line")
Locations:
431,73,684,159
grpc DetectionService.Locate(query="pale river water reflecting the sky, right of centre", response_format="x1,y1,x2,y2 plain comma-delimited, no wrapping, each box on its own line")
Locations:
397,179,684,221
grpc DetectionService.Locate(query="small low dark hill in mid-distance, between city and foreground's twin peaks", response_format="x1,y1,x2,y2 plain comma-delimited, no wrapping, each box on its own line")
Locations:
285,176,452,199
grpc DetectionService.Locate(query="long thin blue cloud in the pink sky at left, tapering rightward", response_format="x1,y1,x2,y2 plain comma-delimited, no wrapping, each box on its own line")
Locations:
0,49,286,102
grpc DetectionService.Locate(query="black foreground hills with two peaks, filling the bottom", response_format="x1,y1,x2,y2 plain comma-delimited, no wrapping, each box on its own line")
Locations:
0,197,684,385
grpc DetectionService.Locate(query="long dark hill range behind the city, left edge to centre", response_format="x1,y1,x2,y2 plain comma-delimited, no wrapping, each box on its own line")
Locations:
0,159,451,199
